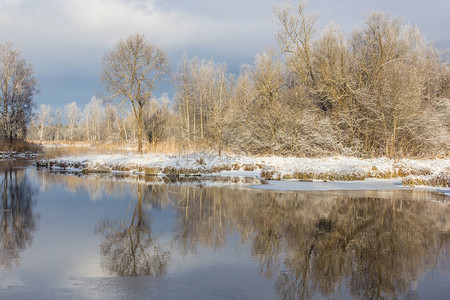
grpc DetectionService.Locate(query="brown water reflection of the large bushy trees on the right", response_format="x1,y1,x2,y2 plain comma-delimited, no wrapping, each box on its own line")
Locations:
277,198,449,298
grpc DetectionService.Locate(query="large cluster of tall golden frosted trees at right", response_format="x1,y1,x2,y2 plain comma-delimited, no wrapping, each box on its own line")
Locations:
275,2,450,157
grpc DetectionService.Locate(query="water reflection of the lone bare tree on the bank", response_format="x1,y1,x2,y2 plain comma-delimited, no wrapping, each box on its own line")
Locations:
97,184,169,276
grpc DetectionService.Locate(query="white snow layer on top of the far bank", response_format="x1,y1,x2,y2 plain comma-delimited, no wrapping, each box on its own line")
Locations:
40,153,450,176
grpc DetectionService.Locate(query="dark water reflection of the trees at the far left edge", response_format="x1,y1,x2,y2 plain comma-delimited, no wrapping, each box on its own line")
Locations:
0,169,39,268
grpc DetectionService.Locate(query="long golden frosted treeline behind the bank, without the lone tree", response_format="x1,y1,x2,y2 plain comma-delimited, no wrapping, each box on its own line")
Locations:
31,3,450,157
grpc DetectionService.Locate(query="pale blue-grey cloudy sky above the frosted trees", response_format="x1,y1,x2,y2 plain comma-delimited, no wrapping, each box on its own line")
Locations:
0,0,450,107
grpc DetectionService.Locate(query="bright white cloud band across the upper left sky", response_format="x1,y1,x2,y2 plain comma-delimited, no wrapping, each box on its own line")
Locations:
0,0,272,53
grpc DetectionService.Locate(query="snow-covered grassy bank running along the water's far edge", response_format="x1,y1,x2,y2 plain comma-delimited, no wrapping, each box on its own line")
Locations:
36,153,450,187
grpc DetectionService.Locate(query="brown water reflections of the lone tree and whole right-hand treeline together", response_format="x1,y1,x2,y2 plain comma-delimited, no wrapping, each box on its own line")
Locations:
36,171,450,299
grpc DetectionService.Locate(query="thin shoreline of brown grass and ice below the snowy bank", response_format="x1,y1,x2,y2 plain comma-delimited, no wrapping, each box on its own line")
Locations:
30,168,450,198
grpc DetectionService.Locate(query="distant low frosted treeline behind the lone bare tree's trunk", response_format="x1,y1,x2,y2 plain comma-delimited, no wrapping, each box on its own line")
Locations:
28,94,174,144
